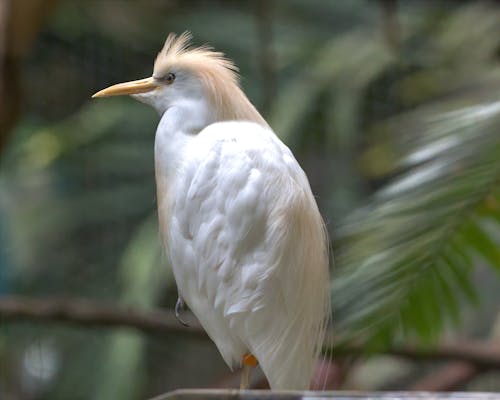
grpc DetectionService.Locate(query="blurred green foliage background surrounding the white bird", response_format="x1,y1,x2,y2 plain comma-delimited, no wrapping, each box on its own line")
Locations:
0,0,500,400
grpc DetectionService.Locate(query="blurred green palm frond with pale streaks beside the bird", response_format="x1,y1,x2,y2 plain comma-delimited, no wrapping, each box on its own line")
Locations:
332,80,500,340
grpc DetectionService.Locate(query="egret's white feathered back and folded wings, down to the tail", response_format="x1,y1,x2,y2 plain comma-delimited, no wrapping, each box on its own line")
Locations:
160,121,329,389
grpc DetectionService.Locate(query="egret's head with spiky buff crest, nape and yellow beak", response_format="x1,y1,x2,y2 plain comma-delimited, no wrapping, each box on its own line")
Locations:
92,32,267,126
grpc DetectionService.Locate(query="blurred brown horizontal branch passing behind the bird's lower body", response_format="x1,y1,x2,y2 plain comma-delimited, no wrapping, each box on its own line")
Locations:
0,296,500,369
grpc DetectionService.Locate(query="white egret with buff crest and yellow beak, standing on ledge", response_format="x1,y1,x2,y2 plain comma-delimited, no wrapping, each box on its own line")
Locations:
93,32,330,389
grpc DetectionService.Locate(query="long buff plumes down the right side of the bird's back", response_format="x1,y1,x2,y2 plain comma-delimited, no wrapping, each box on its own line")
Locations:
246,188,331,390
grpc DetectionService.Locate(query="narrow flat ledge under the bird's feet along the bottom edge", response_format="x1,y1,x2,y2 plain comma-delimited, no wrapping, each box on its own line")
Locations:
151,389,500,400
